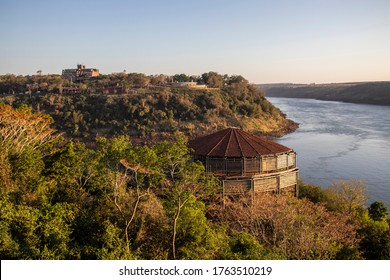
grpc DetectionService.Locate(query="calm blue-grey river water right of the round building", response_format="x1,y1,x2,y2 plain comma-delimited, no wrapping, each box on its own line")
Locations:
268,98,390,206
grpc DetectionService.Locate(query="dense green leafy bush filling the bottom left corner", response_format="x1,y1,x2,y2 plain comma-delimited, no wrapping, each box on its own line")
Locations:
0,199,76,259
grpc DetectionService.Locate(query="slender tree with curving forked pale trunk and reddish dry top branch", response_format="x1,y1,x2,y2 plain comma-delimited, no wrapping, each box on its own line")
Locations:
99,137,168,254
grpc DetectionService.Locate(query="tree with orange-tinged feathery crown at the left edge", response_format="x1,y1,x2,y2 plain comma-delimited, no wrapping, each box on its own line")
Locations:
0,104,58,204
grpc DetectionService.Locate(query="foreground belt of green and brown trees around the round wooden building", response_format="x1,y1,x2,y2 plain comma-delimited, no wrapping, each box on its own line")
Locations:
0,104,390,259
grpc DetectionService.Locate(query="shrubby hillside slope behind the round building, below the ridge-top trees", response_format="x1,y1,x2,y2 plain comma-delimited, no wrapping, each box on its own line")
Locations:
0,79,297,142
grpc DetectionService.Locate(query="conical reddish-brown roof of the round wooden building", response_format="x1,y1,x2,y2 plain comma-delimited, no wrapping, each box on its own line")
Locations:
189,128,292,157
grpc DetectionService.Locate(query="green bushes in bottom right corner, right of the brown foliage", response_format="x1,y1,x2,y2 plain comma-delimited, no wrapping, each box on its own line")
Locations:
300,180,390,260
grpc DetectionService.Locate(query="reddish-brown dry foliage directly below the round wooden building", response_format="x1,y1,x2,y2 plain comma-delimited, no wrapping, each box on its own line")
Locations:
213,194,358,259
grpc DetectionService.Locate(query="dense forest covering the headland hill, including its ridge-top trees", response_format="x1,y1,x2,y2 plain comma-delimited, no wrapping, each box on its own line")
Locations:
0,72,297,141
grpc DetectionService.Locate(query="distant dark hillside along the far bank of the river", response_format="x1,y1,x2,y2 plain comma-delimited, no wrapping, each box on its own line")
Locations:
258,82,390,105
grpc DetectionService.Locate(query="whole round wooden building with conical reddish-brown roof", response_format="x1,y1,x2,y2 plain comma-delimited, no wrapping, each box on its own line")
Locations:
189,128,298,196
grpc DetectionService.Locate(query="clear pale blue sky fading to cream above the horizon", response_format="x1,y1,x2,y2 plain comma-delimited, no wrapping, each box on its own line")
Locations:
0,0,390,83
